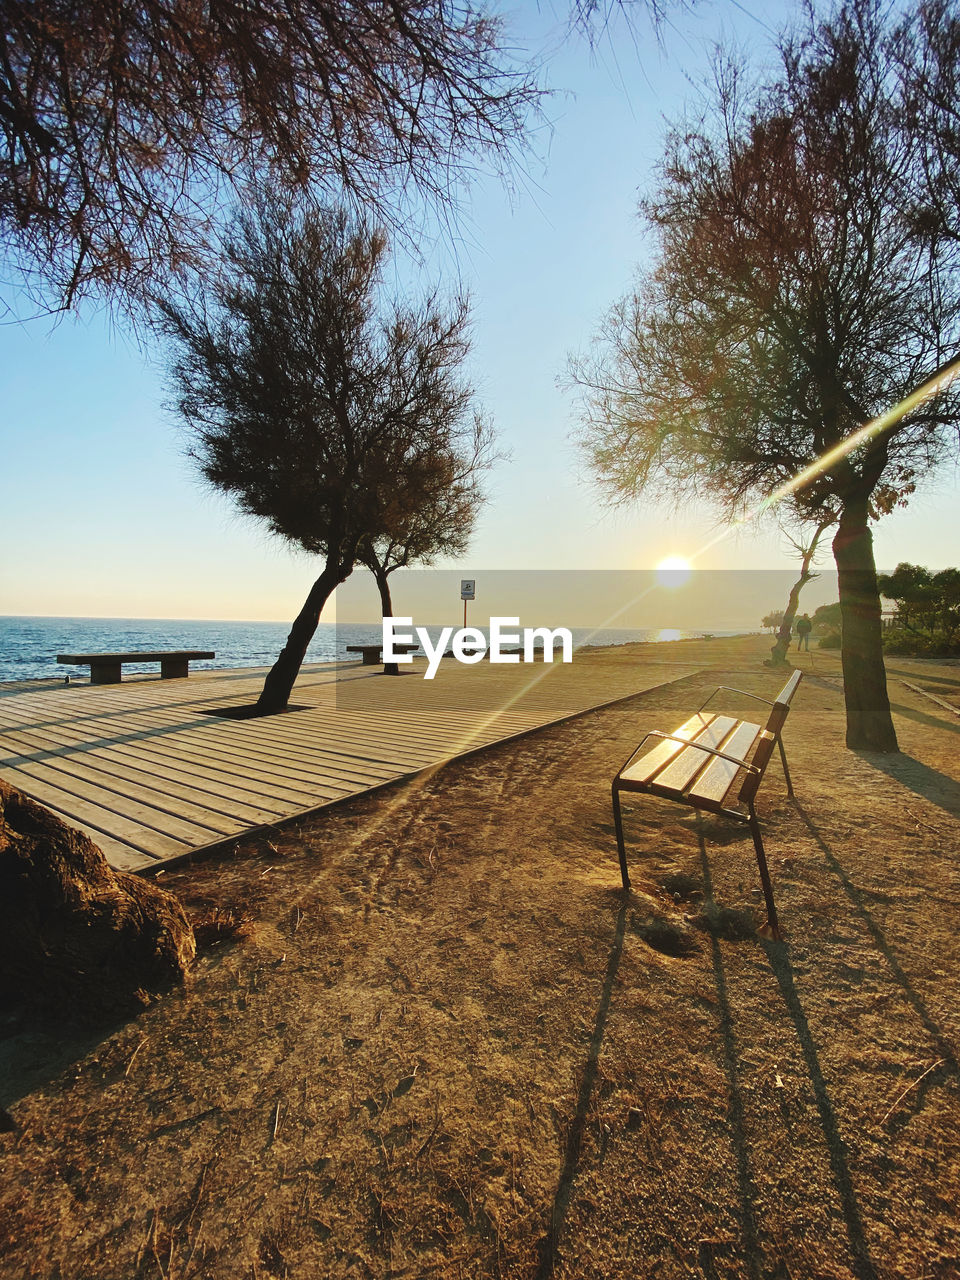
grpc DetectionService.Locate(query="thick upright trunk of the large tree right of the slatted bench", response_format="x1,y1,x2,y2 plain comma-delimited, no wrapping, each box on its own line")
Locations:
833,499,900,751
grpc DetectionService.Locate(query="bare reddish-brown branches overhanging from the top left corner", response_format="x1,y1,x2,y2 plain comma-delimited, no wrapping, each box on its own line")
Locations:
0,0,540,307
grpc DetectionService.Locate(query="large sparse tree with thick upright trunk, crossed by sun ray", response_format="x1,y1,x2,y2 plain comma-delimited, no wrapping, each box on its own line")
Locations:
572,0,960,751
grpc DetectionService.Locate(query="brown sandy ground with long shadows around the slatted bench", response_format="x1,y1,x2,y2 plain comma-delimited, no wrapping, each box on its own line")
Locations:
0,639,960,1280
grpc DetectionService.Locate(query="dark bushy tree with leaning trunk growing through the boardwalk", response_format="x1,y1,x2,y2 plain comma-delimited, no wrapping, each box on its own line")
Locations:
161,201,488,714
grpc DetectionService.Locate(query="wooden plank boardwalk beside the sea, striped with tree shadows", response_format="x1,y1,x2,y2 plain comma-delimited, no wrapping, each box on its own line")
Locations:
0,653,698,870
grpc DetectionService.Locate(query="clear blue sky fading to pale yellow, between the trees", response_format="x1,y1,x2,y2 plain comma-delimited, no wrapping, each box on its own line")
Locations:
0,0,960,621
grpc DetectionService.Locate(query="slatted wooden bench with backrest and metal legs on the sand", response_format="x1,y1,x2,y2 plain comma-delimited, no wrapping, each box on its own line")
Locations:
613,671,803,938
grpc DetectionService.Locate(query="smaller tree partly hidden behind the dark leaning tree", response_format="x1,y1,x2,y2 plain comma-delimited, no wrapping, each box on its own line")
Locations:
358,413,497,676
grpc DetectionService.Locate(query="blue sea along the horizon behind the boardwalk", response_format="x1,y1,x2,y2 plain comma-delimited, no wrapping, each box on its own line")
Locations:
0,617,739,682
